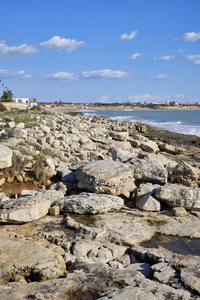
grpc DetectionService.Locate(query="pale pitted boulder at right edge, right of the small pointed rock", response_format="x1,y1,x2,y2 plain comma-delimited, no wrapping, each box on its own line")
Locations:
156,183,200,210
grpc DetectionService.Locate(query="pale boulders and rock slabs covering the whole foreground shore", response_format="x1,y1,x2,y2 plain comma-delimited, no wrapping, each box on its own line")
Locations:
0,111,200,300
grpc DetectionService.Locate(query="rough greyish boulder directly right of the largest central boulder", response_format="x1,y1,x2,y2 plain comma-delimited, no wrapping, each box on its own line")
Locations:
129,158,168,184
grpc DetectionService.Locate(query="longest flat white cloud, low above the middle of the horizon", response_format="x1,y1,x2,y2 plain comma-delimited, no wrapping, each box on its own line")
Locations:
82,69,129,79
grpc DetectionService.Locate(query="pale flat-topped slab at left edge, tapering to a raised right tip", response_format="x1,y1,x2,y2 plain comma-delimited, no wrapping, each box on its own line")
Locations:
0,190,63,223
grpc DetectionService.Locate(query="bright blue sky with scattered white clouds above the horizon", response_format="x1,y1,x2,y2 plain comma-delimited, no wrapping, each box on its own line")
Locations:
0,0,200,103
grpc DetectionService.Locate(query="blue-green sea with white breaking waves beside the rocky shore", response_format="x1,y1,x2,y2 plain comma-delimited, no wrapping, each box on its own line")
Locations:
81,109,200,137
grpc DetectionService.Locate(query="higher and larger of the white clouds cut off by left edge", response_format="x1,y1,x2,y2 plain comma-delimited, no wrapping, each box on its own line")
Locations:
0,41,38,57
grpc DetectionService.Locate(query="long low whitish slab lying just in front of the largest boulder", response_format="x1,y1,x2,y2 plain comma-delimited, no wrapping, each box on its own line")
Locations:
54,193,124,214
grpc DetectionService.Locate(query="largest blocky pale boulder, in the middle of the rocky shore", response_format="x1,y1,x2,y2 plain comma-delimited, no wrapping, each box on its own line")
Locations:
75,160,135,197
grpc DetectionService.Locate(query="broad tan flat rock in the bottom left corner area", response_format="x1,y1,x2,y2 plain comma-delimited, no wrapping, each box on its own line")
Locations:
0,235,65,284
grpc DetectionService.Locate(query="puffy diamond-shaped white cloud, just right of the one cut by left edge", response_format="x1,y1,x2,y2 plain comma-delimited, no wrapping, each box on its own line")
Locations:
40,36,85,53
